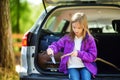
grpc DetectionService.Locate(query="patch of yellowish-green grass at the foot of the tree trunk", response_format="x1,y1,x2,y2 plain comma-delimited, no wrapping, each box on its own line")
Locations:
0,68,19,80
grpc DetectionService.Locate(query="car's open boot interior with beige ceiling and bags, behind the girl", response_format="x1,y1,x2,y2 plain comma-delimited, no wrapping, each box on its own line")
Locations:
37,6,120,75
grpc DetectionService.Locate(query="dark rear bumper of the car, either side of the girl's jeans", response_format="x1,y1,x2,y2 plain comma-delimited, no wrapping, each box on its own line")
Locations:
20,74,120,80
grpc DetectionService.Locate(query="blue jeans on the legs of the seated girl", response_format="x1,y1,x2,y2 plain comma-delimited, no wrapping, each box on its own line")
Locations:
68,68,91,80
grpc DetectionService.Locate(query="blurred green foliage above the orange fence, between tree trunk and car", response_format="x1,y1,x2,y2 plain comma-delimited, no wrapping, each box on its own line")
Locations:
10,0,43,33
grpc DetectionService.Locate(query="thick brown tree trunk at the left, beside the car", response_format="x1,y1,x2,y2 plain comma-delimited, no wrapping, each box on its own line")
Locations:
0,0,15,70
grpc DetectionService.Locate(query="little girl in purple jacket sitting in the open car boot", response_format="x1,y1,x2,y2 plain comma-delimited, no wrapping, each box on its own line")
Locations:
47,13,97,80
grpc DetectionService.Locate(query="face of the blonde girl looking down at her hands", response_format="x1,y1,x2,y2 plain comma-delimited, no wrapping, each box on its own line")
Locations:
72,21,83,37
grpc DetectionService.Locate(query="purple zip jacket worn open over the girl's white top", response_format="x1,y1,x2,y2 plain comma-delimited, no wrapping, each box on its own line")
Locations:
49,34,97,75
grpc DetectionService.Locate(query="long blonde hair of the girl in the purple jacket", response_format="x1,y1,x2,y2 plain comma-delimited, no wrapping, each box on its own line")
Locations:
70,13,91,39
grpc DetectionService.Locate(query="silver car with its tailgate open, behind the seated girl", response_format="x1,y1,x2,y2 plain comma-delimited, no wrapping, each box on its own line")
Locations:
19,0,120,80
